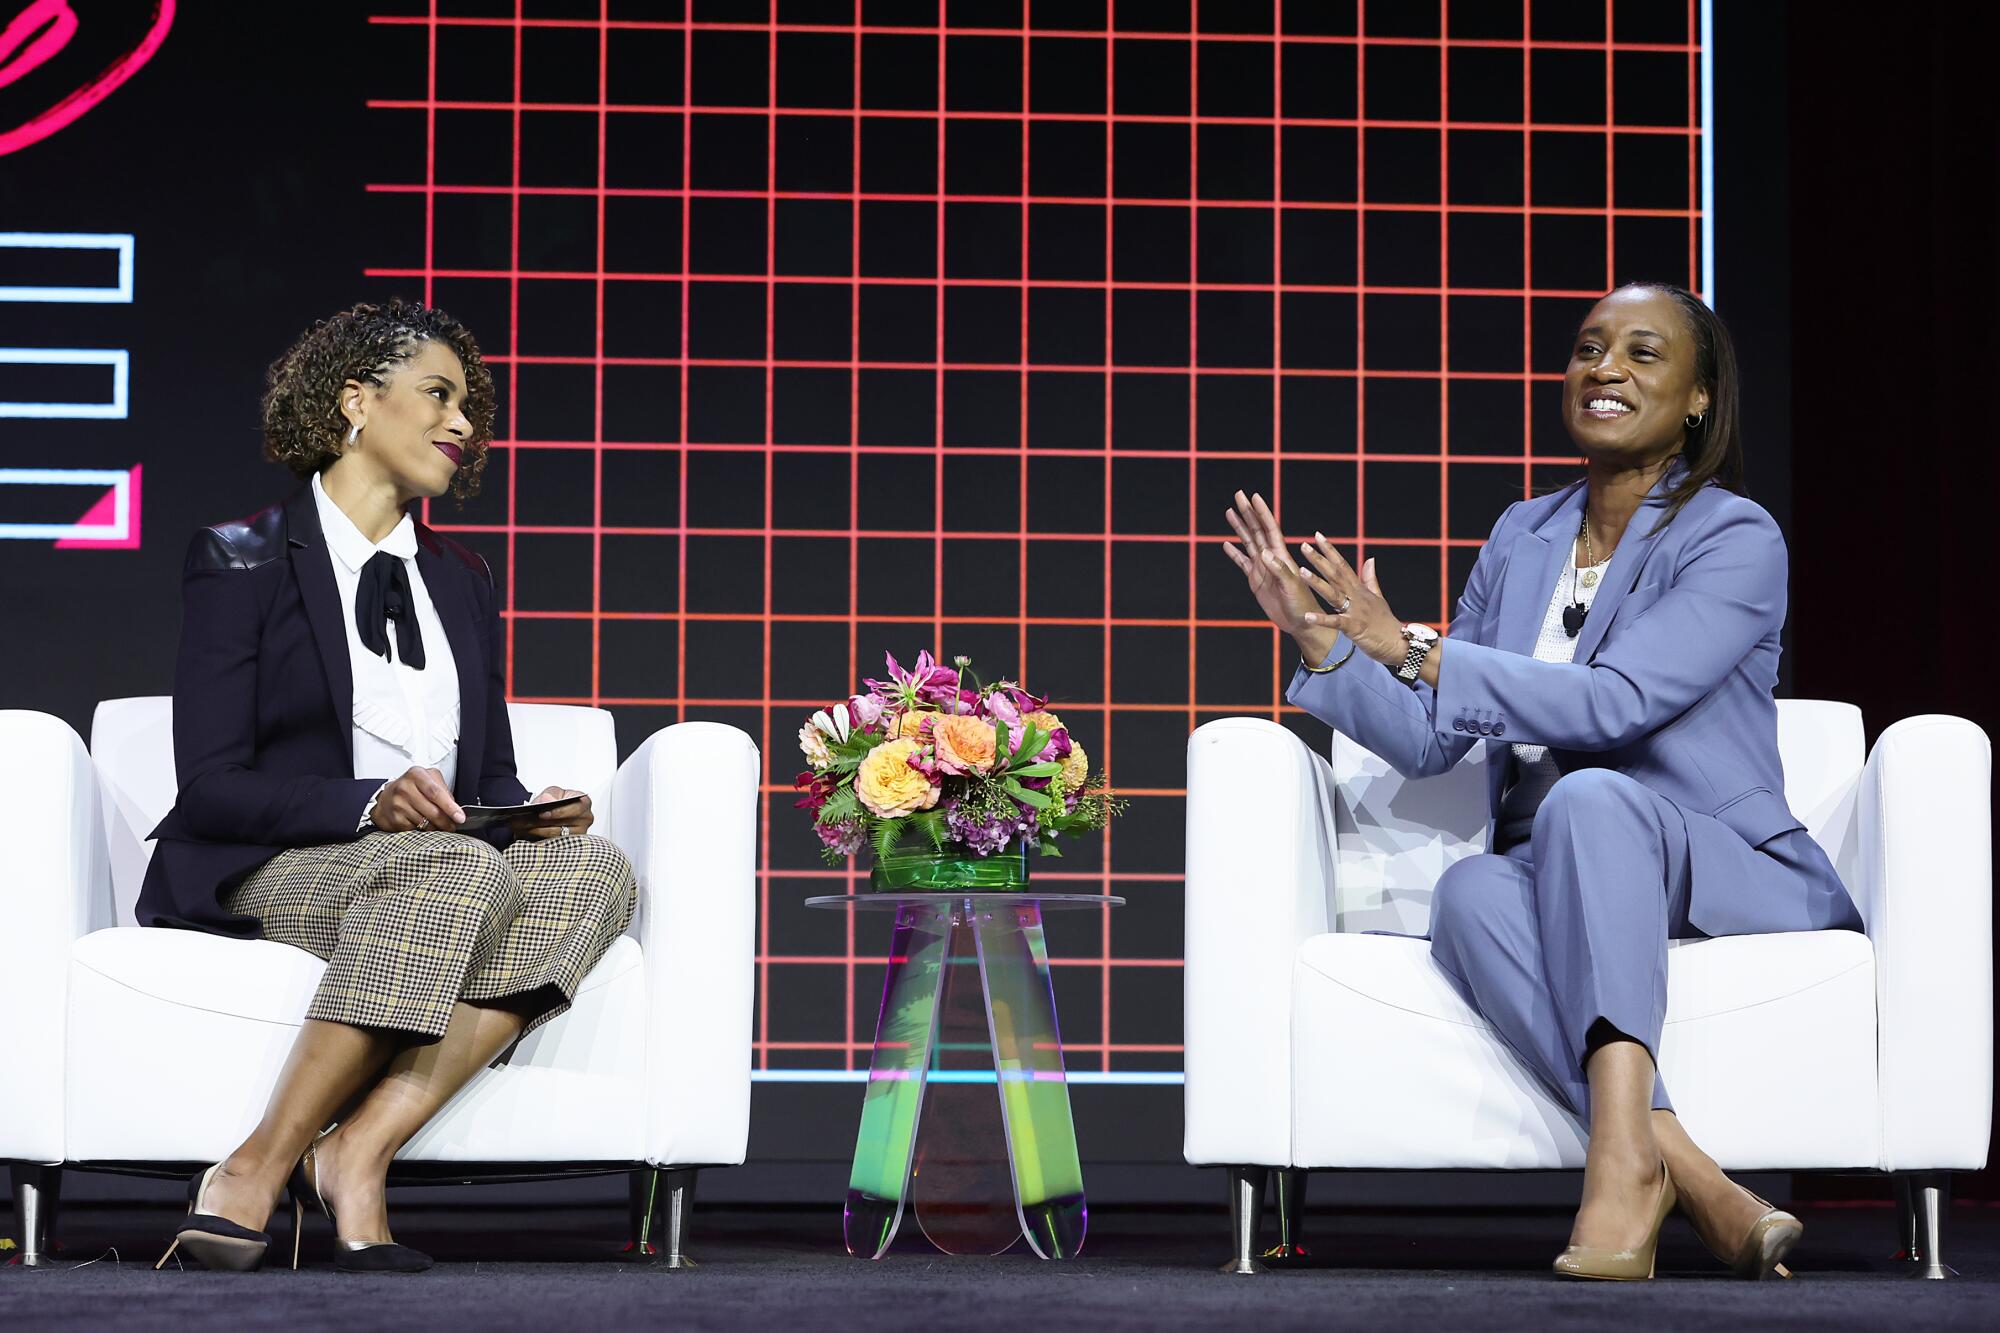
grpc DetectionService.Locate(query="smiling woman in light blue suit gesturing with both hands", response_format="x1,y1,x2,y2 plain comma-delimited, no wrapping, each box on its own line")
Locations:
1224,284,1860,1279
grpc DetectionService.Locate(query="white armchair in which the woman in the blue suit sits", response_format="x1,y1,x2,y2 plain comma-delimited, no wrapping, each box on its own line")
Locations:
1184,701,1992,1277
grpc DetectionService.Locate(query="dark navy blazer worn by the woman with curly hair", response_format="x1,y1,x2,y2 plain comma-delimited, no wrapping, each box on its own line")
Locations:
136,486,528,937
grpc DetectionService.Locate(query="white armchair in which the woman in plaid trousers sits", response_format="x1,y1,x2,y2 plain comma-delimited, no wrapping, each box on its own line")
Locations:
0,699,760,1267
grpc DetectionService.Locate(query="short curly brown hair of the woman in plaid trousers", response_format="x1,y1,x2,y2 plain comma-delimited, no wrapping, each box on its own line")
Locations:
264,300,494,500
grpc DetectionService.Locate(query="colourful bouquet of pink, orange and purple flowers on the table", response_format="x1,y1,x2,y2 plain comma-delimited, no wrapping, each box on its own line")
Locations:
792,650,1124,863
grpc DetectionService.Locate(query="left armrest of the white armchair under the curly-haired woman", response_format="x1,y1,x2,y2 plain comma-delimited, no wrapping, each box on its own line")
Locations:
0,709,112,1161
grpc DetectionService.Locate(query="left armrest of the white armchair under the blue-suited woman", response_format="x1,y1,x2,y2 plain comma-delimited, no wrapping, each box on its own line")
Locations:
1182,717,1334,1167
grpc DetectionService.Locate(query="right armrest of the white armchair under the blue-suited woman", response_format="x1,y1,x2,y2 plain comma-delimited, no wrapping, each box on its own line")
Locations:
1848,715,1994,1171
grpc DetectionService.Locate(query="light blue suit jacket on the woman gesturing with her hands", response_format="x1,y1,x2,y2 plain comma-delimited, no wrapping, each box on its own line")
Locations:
1286,468,1860,935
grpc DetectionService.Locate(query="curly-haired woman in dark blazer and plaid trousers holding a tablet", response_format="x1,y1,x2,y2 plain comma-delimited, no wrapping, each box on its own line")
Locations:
138,302,636,1273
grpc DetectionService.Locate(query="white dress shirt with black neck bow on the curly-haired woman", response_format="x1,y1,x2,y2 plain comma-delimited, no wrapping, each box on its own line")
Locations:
312,474,458,808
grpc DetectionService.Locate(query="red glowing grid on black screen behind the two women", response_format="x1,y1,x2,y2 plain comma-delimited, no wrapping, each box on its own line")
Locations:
368,0,1702,1077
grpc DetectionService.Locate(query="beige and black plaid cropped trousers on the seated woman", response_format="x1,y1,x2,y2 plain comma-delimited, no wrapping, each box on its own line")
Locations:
222,831,638,1041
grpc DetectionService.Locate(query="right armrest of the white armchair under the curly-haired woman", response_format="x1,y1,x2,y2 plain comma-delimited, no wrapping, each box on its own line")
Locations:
612,723,762,1167
